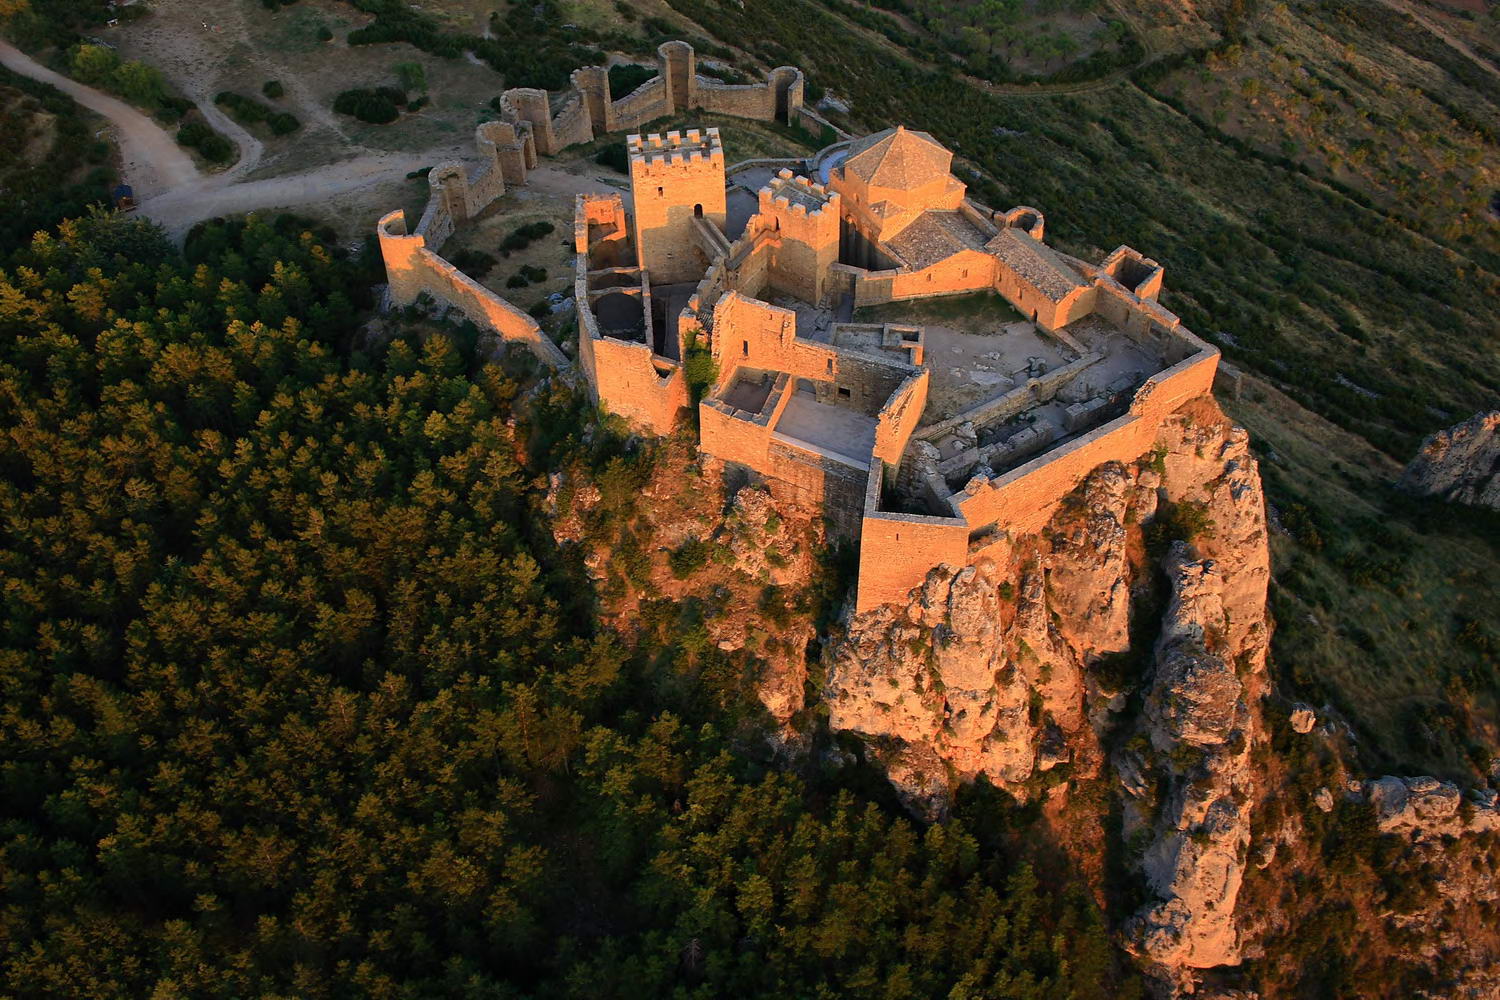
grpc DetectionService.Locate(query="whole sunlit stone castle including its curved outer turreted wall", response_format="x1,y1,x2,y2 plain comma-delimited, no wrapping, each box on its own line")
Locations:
380,42,1218,612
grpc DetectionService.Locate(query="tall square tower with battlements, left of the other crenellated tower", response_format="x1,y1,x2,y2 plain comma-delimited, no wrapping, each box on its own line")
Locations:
626,129,728,285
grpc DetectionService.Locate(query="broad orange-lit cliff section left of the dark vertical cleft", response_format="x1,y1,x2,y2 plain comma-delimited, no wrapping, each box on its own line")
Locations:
825,463,1155,817
